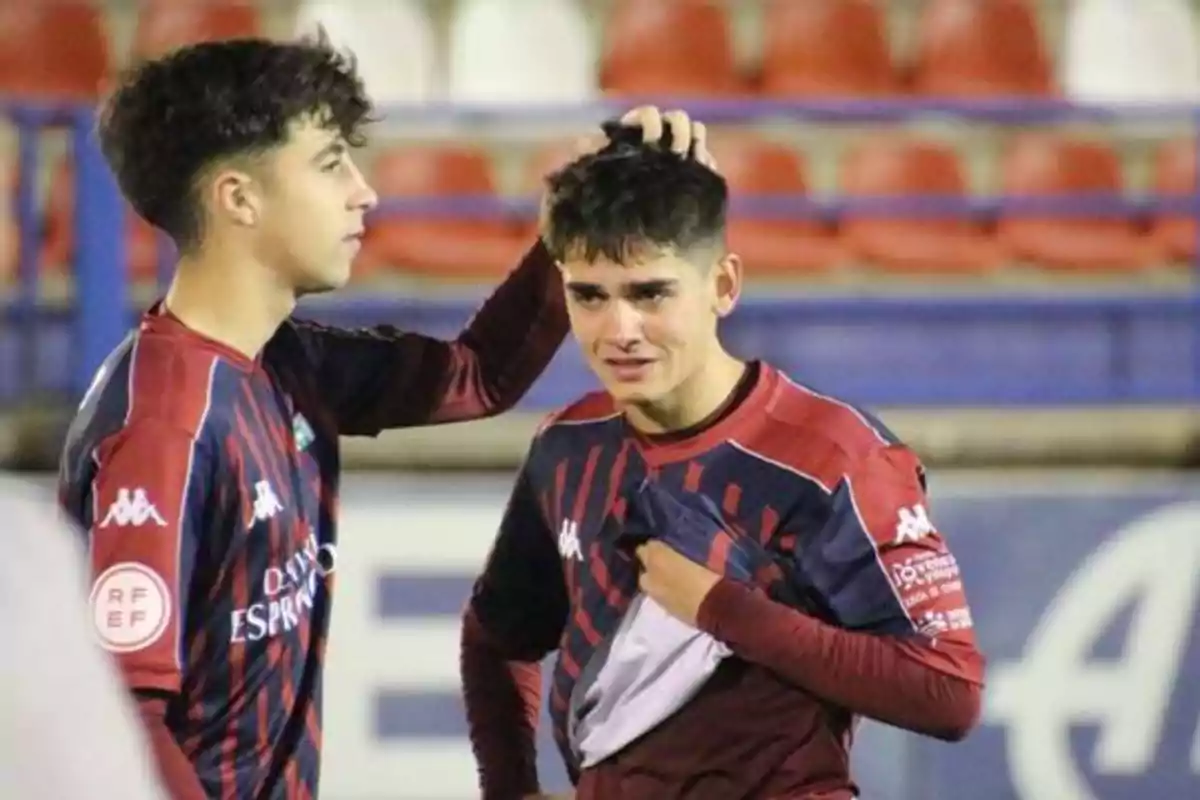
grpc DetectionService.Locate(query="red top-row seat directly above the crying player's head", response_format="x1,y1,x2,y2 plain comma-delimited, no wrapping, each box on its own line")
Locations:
600,0,745,97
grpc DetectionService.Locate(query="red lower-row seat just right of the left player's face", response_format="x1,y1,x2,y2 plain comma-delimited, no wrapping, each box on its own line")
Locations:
364,145,529,281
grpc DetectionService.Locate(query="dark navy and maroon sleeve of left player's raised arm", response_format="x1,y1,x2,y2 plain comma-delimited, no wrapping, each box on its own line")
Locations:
296,241,568,435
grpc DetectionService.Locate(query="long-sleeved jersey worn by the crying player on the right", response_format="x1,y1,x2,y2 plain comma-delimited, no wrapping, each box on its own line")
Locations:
462,365,983,800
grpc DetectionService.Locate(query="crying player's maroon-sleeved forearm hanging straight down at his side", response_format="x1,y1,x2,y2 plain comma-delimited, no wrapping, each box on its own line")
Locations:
460,609,541,800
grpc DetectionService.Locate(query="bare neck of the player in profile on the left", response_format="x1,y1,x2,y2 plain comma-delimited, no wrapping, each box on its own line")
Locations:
166,252,295,359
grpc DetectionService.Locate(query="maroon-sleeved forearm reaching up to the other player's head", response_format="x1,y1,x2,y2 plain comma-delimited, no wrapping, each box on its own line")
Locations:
433,240,569,422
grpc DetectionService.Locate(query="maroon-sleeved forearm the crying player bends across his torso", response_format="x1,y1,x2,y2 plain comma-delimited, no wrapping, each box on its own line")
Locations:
697,581,982,741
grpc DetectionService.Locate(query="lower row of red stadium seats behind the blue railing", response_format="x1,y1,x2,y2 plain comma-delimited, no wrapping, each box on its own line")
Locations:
8,132,1198,281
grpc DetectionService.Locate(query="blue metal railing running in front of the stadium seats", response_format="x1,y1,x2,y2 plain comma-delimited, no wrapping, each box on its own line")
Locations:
0,98,1200,402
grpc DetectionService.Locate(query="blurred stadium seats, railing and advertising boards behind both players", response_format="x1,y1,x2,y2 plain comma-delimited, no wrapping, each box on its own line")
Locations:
0,0,1200,800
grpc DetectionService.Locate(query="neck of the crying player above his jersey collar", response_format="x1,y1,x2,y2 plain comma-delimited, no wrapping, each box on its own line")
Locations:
624,349,746,435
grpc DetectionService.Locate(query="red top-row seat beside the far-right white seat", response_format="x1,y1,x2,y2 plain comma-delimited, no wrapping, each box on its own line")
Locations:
912,0,1055,97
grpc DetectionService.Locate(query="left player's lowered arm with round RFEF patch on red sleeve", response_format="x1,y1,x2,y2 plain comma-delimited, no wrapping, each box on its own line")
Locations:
85,420,212,800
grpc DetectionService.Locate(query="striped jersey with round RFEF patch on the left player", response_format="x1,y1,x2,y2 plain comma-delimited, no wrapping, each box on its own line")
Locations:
60,247,566,800
